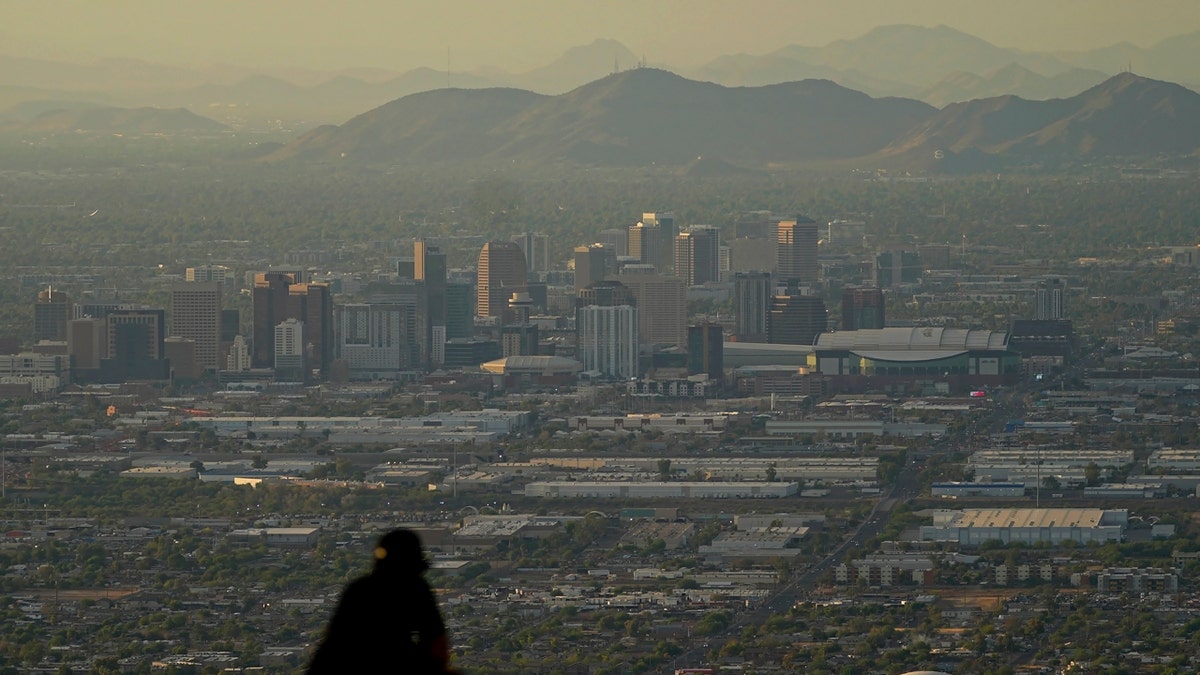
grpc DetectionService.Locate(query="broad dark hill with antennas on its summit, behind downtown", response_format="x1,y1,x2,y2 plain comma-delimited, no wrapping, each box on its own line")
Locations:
272,68,936,166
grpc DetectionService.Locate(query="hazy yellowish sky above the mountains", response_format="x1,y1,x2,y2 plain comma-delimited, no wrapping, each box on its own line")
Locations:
7,0,1200,72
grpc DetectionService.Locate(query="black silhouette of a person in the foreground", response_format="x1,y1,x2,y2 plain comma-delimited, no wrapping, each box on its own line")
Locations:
308,530,452,675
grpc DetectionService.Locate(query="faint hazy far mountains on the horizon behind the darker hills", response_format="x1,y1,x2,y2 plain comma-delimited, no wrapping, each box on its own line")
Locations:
0,25,1200,130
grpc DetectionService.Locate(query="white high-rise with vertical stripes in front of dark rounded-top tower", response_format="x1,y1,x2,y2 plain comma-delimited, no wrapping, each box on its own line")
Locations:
575,305,637,380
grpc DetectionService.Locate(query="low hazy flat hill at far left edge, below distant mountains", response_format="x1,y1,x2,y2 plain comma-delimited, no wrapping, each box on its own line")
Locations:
0,107,228,135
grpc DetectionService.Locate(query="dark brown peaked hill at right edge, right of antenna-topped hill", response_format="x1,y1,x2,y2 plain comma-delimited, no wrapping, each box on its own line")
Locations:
877,73,1200,167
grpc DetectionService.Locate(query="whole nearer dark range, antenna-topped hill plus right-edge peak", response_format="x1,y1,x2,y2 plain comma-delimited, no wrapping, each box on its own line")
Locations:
268,68,1200,172
